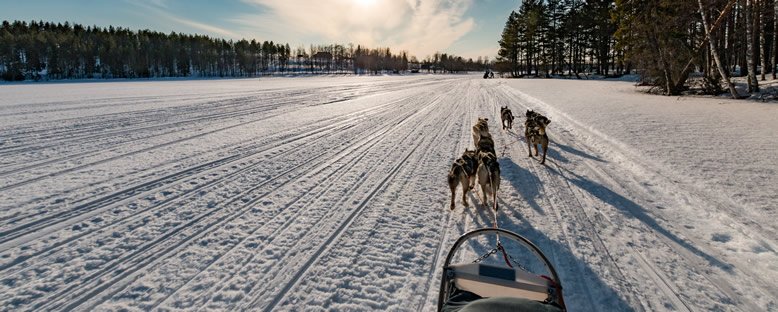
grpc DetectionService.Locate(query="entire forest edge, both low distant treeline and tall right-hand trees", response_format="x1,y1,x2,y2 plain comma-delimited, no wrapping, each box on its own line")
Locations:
6,0,778,98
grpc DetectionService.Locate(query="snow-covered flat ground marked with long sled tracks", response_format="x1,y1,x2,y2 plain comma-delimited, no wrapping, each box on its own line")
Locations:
0,75,778,311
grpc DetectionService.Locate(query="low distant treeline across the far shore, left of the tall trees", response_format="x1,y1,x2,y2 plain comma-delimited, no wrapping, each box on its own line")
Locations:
0,21,488,81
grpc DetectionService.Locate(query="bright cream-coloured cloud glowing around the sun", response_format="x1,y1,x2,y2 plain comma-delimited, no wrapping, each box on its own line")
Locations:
233,0,474,58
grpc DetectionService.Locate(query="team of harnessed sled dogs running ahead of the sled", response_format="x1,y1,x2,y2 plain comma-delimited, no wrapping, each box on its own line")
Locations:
448,106,551,210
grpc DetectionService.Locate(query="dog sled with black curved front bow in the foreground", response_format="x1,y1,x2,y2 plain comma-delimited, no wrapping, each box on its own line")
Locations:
438,228,566,312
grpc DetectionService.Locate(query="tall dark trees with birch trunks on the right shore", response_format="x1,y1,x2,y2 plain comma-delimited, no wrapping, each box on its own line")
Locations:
496,0,778,98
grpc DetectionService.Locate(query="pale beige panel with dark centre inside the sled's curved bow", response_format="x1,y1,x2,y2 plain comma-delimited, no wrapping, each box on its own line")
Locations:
447,263,554,302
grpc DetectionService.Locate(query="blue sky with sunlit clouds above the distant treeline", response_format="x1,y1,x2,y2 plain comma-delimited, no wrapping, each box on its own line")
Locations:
0,0,519,60
